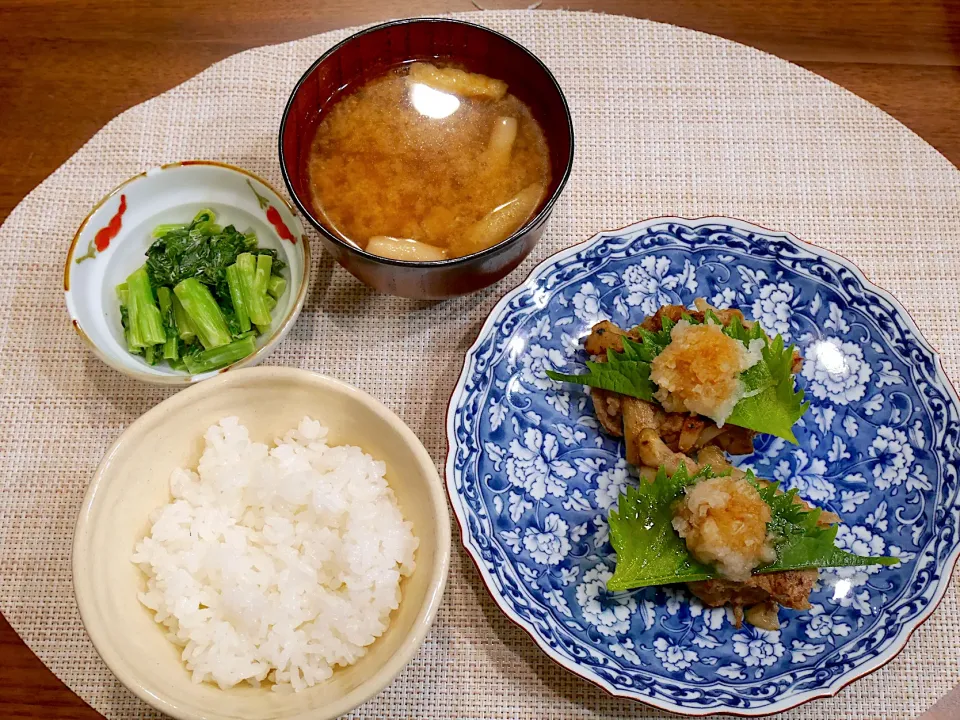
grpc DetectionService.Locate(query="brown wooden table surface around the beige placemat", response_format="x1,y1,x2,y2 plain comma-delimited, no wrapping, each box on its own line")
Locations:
0,0,960,720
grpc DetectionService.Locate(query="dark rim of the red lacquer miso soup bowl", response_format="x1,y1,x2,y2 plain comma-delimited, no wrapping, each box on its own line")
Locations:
277,17,576,269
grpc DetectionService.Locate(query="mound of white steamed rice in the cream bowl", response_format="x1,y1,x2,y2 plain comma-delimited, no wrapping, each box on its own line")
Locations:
133,417,418,690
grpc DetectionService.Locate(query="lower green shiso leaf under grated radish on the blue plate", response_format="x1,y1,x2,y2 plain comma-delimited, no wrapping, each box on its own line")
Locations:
607,465,899,591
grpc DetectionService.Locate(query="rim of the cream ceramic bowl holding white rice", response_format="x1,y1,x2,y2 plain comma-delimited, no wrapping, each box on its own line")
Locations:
71,366,452,720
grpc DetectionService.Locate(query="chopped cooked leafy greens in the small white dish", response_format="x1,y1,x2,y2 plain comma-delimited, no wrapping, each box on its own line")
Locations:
117,210,286,375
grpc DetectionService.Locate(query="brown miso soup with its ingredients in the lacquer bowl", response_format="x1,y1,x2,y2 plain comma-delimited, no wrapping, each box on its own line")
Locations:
309,62,550,261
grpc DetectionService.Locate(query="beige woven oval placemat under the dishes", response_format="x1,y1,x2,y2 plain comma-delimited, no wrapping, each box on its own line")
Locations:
0,11,960,720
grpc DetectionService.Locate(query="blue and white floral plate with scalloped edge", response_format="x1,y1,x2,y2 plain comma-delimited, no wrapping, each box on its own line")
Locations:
447,218,960,715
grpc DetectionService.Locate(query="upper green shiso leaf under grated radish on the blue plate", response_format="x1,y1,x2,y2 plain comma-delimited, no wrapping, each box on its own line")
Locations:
547,311,809,443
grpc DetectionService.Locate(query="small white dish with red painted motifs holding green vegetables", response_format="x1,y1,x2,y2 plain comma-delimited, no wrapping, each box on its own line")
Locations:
63,160,310,386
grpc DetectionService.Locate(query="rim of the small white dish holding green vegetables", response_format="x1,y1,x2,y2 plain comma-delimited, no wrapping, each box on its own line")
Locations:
63,160,310,387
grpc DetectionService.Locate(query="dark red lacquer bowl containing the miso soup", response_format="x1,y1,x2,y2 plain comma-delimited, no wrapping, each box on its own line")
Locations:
280,18,573,298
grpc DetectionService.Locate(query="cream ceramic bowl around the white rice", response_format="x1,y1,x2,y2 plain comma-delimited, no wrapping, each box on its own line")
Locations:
73,368,450,720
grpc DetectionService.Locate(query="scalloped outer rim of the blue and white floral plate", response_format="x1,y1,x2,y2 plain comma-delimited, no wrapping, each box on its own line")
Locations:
444,215,960,717
